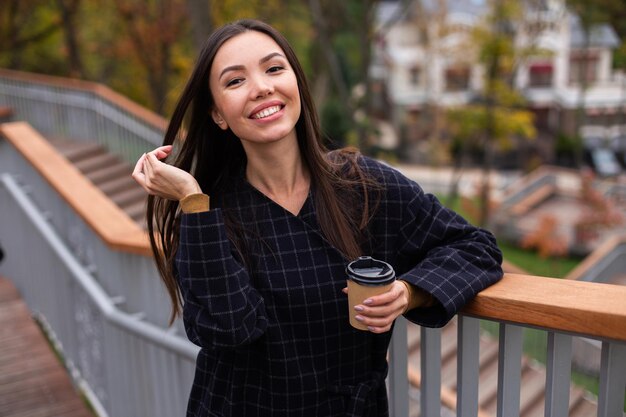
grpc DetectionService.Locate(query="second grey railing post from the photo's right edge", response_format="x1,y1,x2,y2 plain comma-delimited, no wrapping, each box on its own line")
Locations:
545,332,572,417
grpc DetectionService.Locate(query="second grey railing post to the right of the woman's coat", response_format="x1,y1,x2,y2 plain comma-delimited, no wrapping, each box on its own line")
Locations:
420,327,441,417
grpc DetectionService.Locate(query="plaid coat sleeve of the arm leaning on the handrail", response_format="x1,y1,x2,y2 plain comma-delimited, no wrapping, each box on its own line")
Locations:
376,164,502,327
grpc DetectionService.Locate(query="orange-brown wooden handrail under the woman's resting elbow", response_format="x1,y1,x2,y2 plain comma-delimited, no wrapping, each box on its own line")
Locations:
463,274,626,342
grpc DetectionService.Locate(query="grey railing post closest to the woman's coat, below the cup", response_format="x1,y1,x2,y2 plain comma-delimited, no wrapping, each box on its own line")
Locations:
388,317,409,417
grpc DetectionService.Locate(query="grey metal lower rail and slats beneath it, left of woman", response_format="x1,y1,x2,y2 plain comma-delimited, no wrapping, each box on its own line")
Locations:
0,173,198,417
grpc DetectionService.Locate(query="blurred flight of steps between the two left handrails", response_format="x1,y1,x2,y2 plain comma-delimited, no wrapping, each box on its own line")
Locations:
48,138,147,228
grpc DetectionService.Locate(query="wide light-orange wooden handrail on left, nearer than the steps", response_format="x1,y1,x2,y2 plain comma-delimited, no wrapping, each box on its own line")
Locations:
0,122,152,256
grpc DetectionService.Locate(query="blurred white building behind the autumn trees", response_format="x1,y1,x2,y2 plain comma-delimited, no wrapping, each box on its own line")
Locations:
371,0,626,162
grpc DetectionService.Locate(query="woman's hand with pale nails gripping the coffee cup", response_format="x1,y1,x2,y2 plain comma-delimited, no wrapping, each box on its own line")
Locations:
344,281,409,333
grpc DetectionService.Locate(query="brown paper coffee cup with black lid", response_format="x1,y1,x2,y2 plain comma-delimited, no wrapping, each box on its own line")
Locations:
346,256,396,330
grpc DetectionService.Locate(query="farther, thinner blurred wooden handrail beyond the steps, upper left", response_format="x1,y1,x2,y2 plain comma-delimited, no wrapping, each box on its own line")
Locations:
0,68,167,132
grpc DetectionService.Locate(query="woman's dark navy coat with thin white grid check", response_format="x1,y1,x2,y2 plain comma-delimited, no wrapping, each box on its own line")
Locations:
176,158,502,417
